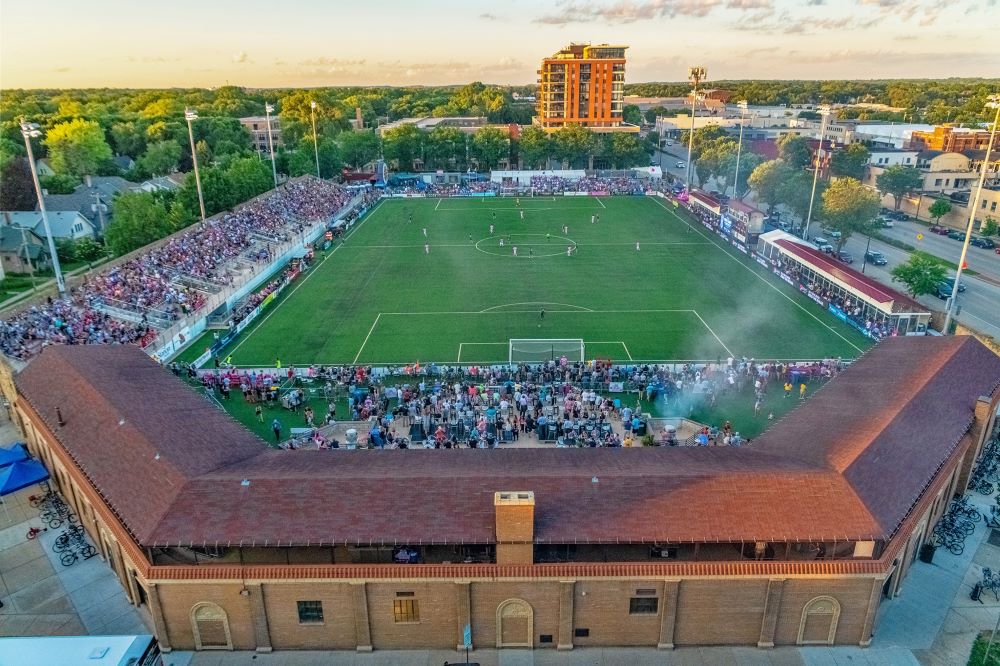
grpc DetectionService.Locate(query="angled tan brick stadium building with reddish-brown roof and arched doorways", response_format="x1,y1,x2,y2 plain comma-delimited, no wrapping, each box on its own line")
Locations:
0,337,1000,651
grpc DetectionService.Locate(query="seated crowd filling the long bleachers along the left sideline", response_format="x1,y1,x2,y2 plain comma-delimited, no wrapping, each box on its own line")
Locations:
0,178,351,359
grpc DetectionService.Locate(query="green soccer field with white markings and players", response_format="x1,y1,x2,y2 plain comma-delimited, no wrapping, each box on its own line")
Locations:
215,197,871,366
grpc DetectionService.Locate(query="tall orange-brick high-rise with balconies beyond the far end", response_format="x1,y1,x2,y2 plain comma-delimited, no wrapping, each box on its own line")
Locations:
534,44,639,132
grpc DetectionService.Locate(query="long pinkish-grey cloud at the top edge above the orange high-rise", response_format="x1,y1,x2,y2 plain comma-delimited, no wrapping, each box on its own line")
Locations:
534,0,774,25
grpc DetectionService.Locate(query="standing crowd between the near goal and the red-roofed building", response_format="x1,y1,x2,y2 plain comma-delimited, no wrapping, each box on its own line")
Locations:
188,358,844,449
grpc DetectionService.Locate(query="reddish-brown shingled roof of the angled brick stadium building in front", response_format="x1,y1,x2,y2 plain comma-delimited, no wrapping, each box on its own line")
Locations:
17,337,1000,546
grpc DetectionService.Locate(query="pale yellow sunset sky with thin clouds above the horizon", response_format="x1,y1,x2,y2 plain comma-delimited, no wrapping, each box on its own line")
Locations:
0,0,1000,88
